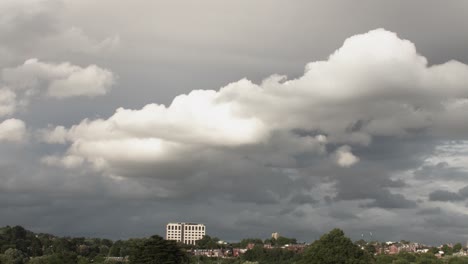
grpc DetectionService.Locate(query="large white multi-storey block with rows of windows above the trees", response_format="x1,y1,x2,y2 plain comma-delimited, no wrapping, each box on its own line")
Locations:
166,223,206,245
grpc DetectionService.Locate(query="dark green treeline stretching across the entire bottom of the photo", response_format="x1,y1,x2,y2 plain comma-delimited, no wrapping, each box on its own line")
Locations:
0,226,468,264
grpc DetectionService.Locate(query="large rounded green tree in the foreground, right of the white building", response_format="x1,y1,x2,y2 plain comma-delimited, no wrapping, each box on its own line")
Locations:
300,228,374,264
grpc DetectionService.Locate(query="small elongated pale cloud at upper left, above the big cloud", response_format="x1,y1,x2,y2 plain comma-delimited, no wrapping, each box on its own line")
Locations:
2,59,115,98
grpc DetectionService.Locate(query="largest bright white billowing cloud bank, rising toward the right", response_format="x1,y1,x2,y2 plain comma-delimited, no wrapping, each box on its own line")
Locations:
42,29,468,176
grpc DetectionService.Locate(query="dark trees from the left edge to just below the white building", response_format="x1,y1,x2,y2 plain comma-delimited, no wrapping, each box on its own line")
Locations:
0,226,186,264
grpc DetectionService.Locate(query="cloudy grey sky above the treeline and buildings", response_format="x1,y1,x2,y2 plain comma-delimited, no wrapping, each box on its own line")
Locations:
0,0,468,245
